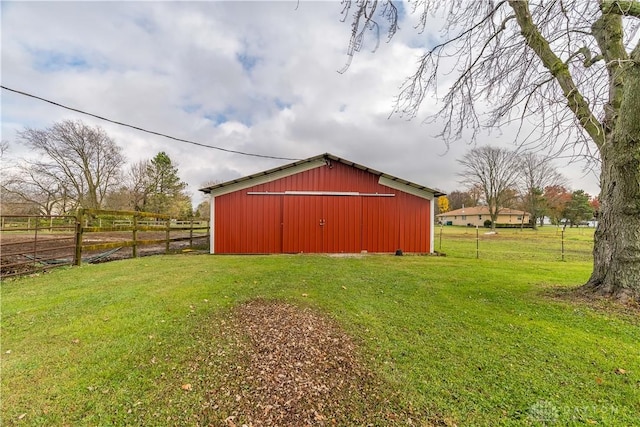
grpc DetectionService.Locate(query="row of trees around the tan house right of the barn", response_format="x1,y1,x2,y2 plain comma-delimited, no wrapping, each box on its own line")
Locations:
437,145,600,228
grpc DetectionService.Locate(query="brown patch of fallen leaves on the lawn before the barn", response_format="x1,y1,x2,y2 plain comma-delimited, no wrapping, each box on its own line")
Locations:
210,300,432,426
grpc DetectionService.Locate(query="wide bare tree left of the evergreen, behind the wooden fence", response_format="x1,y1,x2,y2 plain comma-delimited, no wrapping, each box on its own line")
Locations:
19,120,124,209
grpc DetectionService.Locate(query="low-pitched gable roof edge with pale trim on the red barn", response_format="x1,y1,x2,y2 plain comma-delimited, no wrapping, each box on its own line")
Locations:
200,153,446,197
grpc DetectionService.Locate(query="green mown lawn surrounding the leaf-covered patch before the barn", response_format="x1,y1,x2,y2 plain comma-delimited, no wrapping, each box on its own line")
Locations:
0,227,640,426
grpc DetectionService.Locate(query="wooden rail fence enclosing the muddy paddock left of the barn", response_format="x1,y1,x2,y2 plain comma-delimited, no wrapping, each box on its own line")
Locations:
0,209,209,278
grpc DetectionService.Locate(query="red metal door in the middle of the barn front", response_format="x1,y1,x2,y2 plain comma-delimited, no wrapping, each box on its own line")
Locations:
282,195,362,253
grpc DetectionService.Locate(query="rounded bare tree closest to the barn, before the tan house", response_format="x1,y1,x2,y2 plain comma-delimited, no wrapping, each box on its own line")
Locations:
458,145,518,230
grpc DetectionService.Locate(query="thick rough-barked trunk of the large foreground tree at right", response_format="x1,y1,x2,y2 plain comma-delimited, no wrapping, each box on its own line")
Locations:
584,55,640,301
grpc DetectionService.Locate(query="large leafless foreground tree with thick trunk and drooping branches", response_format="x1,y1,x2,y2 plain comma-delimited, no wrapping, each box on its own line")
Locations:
343,0,640,300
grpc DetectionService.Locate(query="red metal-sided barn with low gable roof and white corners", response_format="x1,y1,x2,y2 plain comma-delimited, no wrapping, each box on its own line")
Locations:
200,154,443,254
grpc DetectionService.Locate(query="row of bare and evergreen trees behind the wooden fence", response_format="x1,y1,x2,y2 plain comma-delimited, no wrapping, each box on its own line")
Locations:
1,120,200,218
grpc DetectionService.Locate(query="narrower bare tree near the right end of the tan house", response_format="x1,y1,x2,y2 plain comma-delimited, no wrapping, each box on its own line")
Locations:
520,152,566,229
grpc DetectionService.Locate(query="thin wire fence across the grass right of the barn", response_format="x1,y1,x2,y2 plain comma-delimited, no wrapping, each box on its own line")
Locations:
434,226,595,262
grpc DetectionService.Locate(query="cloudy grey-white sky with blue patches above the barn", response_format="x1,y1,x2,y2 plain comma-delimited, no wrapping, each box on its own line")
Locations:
0,0,599,206
